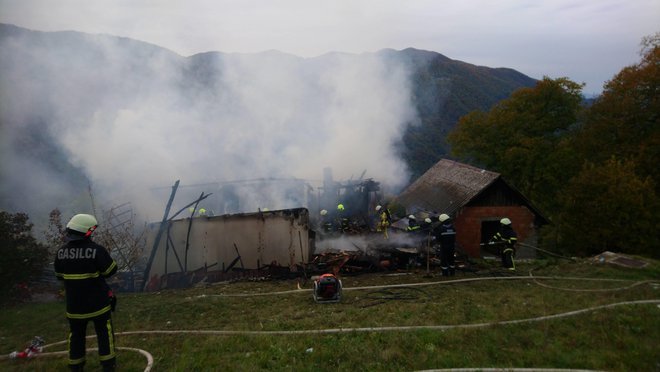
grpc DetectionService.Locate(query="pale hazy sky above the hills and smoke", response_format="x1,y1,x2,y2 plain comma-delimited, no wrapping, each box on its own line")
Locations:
0,0,660,94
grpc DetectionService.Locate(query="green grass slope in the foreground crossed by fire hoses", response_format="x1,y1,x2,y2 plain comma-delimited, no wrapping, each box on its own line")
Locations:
0,260,660,371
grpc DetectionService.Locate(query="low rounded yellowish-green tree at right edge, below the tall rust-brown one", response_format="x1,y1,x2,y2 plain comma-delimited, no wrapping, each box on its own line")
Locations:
558,158,660,256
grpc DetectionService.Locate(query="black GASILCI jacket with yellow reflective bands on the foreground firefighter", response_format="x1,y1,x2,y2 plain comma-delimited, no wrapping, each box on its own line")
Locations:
55,237,117,319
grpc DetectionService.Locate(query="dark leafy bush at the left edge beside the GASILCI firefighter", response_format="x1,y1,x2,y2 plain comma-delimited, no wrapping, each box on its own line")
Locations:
0,211,50,301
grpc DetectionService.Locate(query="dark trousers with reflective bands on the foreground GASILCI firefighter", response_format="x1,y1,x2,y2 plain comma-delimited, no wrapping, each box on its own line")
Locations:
69,311,116,371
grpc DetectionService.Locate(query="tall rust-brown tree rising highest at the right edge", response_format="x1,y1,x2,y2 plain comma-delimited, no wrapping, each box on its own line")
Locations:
574,33,660,192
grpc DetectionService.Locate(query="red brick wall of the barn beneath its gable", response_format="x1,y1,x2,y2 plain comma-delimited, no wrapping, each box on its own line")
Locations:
454,206,536,258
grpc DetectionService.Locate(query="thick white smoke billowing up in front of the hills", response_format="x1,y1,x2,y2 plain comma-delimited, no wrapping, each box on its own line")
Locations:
2,26,415,224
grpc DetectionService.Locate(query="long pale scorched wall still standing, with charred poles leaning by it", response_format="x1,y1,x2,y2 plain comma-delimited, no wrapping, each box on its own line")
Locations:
145,208,314,290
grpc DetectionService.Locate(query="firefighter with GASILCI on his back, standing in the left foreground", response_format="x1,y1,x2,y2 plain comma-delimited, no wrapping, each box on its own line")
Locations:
55,214,117,371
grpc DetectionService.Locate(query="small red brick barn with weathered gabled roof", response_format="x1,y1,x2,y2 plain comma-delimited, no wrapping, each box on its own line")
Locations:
397,159,548,258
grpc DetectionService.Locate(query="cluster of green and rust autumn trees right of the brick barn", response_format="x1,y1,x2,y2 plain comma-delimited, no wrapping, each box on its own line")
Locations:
448,34,660,257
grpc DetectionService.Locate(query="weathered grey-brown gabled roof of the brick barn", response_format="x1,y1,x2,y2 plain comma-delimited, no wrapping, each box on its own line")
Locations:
397,159,546,222
